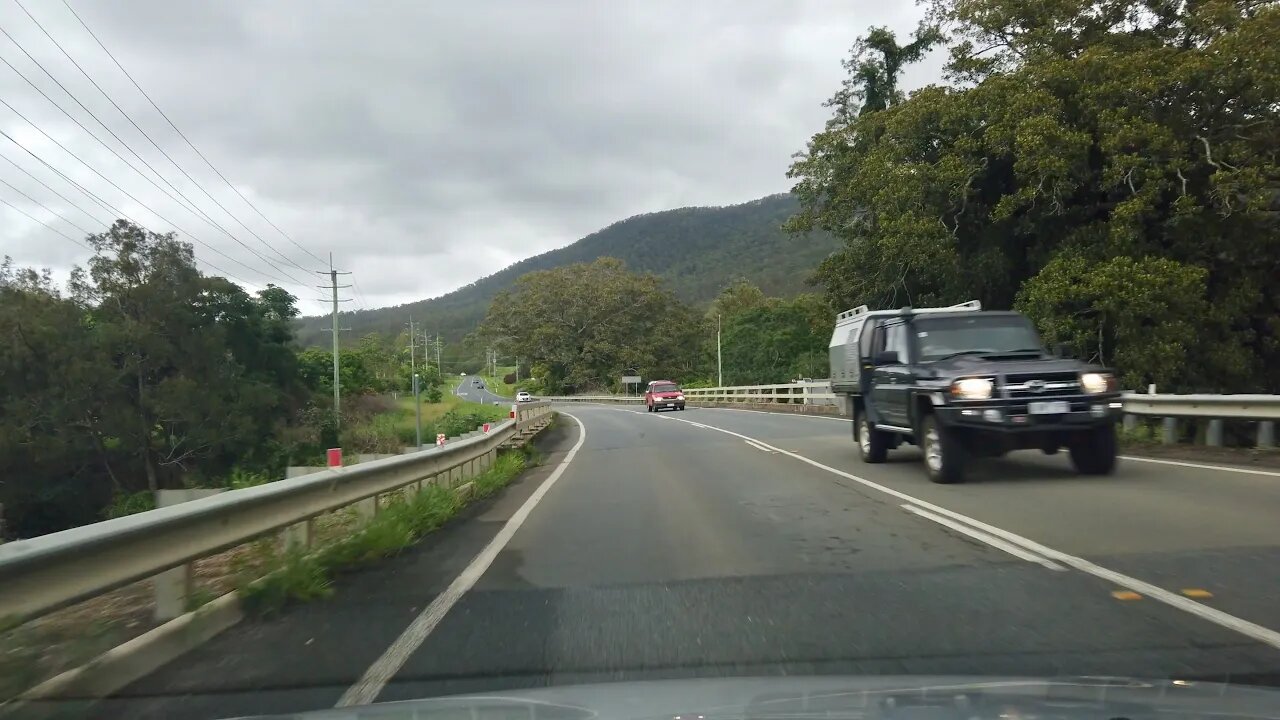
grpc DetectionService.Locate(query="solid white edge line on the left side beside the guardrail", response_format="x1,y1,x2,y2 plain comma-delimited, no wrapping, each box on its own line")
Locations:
334,411,586,707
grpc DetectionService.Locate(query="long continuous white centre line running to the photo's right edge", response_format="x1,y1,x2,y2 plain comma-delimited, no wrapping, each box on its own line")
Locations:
650,409,1280,648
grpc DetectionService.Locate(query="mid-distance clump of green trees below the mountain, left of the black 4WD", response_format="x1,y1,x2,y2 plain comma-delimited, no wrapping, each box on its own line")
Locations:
480,258,833,393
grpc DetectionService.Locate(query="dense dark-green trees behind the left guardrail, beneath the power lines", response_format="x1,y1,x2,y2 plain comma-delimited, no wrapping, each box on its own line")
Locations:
0,220,450,537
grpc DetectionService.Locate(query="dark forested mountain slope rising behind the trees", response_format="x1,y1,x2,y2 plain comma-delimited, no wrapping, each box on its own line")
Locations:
298,193,840,345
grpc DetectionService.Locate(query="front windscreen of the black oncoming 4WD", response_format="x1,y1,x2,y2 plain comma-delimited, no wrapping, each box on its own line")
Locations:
914,315,1042,363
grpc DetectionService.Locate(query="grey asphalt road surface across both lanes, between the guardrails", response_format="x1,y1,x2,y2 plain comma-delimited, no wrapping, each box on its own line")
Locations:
96,405,1280,719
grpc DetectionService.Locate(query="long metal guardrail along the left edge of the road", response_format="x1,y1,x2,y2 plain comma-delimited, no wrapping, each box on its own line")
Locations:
0,402,552,626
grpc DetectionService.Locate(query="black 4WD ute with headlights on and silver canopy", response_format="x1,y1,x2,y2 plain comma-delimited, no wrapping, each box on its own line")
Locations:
831,301,1121,483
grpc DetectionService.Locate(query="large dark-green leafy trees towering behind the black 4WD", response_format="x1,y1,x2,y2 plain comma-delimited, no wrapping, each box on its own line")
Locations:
791,0,1280,392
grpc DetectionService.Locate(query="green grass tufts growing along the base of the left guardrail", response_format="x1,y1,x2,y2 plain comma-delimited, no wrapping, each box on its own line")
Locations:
239,451,531,614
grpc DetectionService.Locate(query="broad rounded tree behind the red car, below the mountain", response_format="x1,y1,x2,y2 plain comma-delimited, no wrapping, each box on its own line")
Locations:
477,258,698,392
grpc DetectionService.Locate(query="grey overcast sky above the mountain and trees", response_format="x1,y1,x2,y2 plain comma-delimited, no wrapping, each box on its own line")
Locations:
0,0,941,314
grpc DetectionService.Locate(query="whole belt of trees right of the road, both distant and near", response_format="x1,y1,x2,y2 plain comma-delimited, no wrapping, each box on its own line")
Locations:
479,0,1280,393
